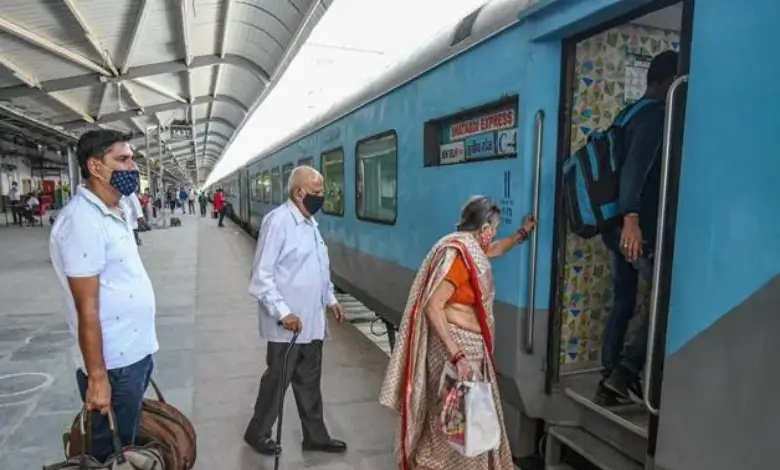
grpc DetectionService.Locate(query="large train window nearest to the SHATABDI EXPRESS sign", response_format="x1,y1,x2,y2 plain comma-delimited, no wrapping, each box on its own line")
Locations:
355,131,398,224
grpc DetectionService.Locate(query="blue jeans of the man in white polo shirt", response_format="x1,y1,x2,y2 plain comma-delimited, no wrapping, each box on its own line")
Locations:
76,356,154,462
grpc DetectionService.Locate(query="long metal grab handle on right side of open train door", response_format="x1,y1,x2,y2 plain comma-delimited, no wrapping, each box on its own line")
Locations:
643,75,688,416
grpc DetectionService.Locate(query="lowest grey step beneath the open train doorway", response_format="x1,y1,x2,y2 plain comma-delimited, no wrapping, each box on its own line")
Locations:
545,426,644,470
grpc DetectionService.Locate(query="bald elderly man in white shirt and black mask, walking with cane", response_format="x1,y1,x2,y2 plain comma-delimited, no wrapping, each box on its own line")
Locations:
244,166,347,455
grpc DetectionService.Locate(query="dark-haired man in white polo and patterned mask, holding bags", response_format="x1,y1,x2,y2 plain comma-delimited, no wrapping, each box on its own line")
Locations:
49,129,158,460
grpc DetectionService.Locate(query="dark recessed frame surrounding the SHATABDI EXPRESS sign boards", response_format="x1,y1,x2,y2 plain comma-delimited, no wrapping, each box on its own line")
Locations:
423,94,522,168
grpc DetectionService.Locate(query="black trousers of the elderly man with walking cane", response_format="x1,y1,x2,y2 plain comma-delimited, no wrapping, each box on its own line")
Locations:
246,341,330,443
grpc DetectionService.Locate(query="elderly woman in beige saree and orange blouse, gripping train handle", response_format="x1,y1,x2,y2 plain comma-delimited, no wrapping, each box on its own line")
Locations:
380,196,536,470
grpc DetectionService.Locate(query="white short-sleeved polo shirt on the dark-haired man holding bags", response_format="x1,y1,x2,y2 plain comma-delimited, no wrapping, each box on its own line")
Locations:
49,186,159,372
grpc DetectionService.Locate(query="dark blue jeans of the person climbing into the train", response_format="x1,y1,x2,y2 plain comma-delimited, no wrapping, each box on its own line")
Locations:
601,229,653,377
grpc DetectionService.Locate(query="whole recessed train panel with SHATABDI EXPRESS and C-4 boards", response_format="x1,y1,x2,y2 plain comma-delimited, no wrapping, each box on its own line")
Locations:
423,95,519,166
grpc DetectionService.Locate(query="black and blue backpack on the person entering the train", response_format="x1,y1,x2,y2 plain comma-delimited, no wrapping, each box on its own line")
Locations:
563,99,657,238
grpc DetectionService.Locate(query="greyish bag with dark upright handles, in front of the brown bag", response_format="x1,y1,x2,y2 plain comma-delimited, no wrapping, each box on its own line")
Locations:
49,408,167,470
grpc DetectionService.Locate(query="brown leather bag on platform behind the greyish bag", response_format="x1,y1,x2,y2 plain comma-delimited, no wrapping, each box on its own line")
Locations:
63,380,197,470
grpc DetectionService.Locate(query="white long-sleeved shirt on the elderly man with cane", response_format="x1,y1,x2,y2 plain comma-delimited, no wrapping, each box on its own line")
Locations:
249,200,336,344
